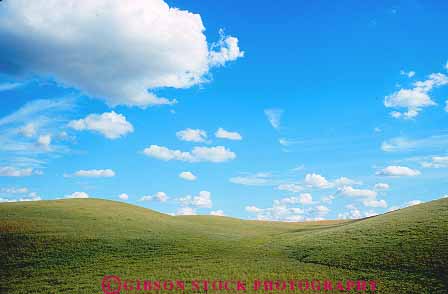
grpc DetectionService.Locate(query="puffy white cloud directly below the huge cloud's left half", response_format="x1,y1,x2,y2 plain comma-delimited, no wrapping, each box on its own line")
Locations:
68,111,134,139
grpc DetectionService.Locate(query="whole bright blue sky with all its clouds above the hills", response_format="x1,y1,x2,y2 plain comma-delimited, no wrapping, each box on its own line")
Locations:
0,0,448,221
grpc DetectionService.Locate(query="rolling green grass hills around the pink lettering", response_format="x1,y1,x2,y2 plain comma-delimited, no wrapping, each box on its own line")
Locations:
0,199,448,293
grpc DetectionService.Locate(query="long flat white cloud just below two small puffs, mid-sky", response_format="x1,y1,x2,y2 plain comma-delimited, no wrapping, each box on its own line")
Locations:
143,145,236,163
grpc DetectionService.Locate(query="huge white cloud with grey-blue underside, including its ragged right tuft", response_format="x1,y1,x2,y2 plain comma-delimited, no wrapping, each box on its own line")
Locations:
0,0,244,107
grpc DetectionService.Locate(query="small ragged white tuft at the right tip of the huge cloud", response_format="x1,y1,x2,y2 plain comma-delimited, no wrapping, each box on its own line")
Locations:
209,29,244,66
